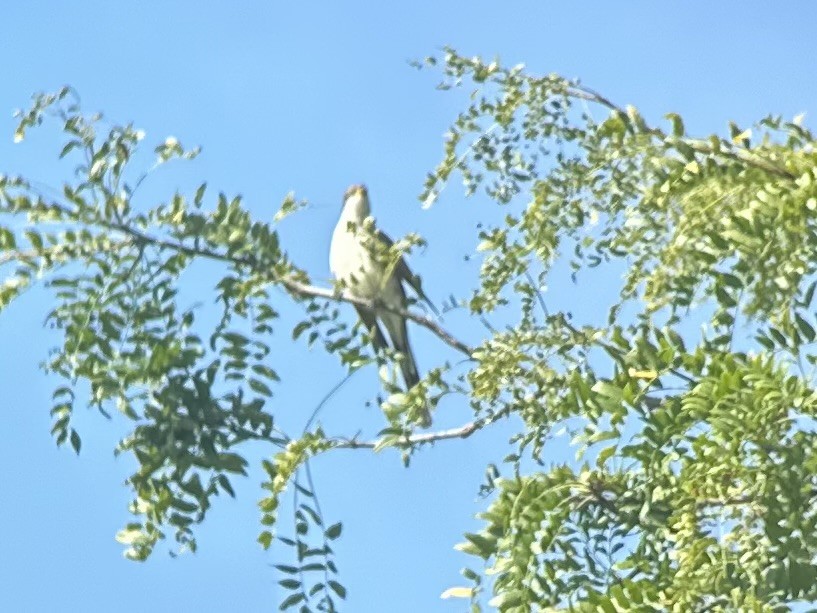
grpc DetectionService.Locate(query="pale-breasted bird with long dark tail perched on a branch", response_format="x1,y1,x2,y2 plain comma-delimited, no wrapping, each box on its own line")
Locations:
329,184,436,427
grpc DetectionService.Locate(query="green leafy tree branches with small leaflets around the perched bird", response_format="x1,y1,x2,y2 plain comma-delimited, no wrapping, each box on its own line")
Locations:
0,45,817,611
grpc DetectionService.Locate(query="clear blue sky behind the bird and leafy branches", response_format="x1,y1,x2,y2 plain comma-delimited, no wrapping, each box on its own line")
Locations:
0,0,817,613
